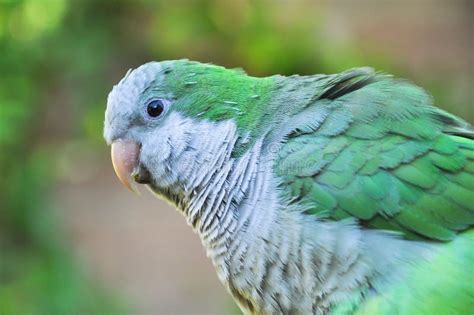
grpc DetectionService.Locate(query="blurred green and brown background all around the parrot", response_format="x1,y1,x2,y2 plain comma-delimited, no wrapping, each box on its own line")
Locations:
0,0,474,314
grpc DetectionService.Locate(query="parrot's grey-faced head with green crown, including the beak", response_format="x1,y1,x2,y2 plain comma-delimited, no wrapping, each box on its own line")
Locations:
104,60,270,200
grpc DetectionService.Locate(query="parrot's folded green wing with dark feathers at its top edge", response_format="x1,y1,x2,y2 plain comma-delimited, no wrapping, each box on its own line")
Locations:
275,69,474,240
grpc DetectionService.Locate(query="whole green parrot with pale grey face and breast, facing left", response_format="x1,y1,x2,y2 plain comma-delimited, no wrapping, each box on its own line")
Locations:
104,59,474,315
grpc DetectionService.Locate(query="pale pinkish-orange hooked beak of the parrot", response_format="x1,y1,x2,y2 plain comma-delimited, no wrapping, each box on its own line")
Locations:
111,139,140,193
